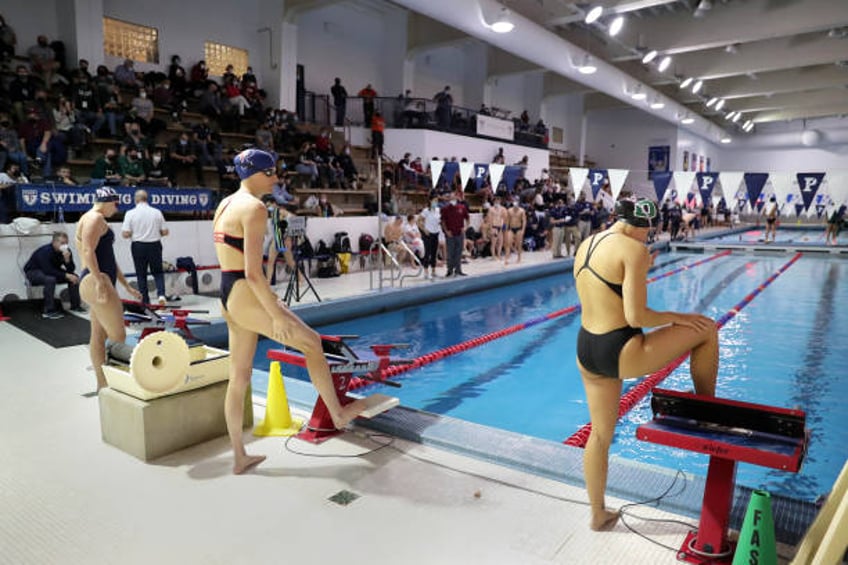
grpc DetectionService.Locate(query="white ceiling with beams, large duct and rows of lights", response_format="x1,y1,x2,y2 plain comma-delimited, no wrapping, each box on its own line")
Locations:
376,0,848,139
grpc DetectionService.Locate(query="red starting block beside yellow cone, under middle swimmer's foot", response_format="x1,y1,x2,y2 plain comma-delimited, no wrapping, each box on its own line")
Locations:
268,336,412,443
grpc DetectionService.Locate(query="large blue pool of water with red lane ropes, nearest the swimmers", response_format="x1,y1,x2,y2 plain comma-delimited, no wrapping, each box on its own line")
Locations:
253,252,848,500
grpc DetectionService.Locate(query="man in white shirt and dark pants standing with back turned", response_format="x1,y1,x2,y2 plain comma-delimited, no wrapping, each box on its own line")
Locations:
121,190,168,306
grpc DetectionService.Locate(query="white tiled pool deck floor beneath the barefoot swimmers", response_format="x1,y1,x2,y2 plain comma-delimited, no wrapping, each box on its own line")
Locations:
0,226,820,565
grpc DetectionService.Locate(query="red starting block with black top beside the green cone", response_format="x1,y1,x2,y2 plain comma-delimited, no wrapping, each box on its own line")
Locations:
636,389,809,564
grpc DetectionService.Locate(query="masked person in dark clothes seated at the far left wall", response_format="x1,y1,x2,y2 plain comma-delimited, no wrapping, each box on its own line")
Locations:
24,231,85,320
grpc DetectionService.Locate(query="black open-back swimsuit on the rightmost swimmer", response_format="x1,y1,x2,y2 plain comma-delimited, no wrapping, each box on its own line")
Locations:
575,233,642,379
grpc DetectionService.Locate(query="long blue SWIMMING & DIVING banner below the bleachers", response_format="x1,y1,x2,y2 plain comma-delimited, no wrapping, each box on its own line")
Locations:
17,184,215,212
